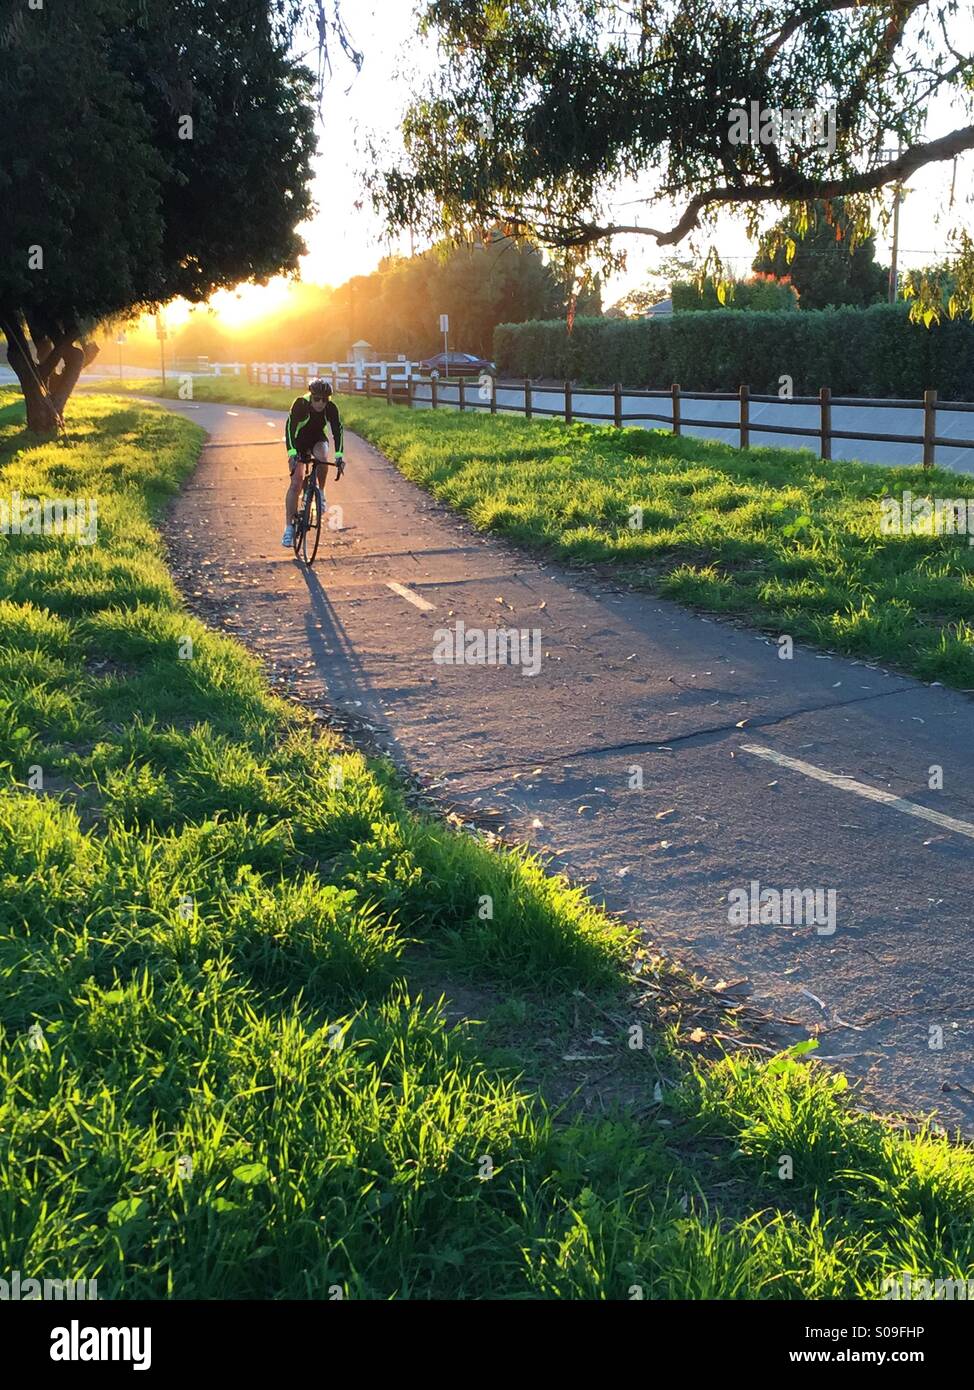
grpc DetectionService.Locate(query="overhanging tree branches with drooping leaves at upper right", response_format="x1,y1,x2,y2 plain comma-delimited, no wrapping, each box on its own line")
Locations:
370,0,974,309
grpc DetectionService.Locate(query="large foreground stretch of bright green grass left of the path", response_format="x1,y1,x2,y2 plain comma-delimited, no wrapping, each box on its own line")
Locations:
0,393,974,1298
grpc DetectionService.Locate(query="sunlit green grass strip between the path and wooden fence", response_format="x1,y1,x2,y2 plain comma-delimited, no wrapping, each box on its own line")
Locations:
110,379,974,689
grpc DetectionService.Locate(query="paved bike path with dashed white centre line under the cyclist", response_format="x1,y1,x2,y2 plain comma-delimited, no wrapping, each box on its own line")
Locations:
160,402,974,1134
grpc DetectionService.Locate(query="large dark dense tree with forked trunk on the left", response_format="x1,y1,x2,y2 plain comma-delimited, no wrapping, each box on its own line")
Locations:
0,0,360,431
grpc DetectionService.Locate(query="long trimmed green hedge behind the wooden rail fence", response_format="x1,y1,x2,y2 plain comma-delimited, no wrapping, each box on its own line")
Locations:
493,304,974,400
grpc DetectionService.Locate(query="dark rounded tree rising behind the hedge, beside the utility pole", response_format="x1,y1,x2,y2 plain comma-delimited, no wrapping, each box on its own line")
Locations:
753,202,889,309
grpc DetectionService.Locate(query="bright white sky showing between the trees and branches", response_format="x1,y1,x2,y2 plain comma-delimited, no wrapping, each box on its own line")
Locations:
193,0,974,327
